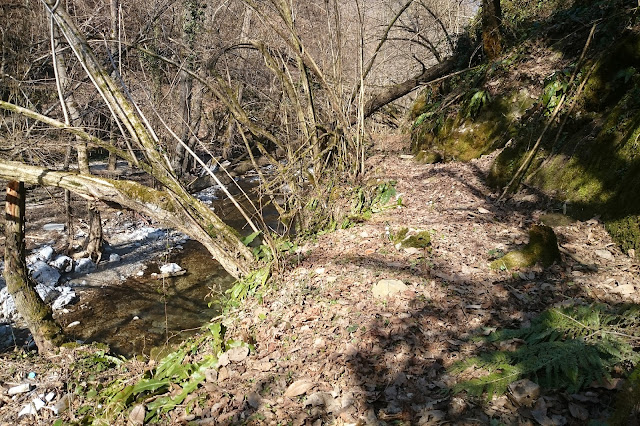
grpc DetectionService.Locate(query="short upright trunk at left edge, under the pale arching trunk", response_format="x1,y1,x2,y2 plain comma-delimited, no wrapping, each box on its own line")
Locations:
4,180,64,354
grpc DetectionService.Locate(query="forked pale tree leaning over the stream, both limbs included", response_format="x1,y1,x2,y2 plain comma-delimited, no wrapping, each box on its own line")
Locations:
37,0,256,278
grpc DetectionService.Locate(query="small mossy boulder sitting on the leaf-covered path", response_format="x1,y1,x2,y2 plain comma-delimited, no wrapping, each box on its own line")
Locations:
489,225,561,270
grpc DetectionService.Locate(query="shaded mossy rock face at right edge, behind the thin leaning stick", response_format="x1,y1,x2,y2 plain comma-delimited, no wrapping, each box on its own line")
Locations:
489,33,640,253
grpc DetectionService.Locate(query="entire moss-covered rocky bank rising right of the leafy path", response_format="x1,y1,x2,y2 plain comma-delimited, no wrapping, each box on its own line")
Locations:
410,0,640,254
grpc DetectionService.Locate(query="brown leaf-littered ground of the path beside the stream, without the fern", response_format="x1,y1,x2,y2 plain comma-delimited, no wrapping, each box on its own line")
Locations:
0,137,640,425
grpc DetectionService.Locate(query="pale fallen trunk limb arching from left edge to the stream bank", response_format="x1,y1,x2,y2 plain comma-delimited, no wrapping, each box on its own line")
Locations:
0,160,255,278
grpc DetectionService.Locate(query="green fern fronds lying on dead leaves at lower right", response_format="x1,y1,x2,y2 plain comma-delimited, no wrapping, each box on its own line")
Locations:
449,305,640,398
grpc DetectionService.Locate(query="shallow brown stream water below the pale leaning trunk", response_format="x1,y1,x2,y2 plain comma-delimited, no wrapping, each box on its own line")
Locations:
59,241,234,356
